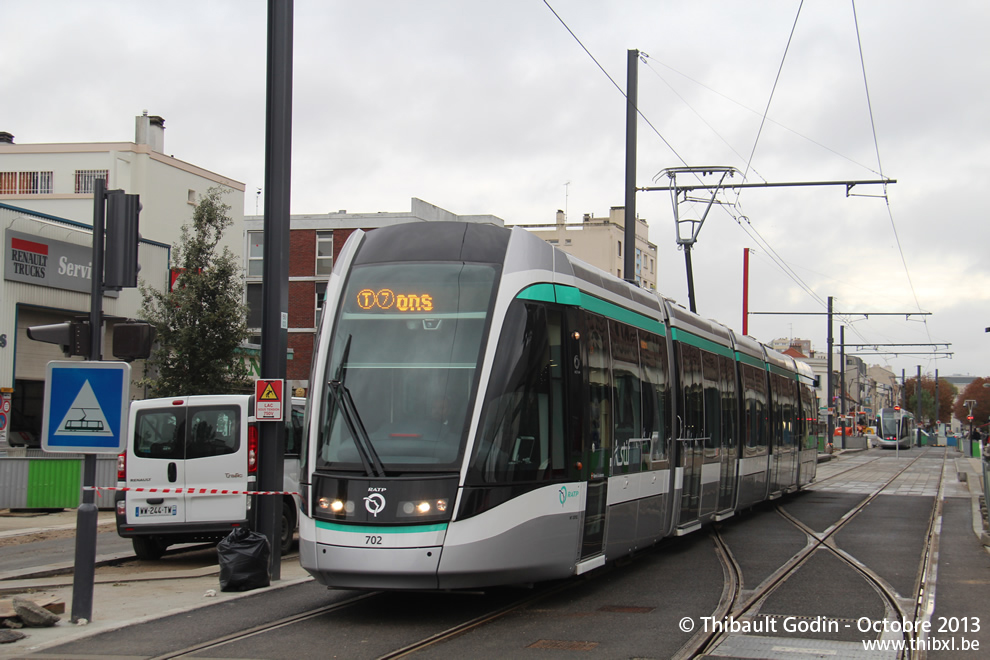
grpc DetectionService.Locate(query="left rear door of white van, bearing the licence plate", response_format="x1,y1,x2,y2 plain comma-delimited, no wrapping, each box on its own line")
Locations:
125,398,186,525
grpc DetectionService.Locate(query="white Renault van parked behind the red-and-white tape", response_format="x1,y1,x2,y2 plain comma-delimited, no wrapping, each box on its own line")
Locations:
115,394,306,559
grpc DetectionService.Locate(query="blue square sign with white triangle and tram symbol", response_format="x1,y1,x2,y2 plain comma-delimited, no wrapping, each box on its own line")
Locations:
41,360,131,454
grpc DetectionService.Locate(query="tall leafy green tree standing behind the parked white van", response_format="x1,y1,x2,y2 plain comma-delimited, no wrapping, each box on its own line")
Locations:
140,187,250,397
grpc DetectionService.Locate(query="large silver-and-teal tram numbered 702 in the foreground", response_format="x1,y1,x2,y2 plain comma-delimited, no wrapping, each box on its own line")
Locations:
299,222,818,589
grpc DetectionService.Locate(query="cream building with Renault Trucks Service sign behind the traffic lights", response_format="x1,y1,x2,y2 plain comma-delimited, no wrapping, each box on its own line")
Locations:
0,114,244,445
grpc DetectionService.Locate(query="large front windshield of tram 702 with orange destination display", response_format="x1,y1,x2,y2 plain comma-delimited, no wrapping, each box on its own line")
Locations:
316,263,496,470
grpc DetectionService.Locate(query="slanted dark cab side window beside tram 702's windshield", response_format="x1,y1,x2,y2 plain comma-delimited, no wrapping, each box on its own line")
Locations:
468,300,563,483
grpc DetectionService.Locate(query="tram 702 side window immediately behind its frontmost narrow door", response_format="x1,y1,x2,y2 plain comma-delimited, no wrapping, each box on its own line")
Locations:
608,321,649,474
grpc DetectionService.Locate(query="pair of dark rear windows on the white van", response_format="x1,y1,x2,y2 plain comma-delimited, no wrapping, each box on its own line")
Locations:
134,406,241,461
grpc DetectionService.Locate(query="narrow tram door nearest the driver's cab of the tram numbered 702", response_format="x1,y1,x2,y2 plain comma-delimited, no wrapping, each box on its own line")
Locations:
578,313,613,559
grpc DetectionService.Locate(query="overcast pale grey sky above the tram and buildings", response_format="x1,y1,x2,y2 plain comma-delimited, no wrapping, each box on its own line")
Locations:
0,0,990,384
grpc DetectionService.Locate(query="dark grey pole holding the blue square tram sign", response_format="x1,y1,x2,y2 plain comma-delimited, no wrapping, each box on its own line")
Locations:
71,178,107,623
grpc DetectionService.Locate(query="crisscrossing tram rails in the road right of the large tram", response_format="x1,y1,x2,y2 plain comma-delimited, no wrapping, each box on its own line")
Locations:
674,452,947,659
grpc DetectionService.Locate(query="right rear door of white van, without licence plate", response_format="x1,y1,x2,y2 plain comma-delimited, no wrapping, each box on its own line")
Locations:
185,396,248,523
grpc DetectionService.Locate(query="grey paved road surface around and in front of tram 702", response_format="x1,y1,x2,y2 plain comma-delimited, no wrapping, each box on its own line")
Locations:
7,449,990,660
